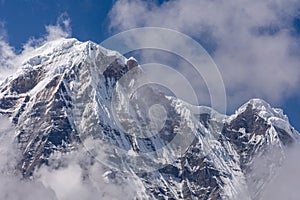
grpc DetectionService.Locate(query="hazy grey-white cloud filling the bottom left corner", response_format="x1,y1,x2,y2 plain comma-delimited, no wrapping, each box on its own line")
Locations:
0,116,56,200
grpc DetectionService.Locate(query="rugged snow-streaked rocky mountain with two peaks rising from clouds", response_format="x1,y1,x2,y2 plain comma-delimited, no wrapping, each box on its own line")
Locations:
0,39,299,199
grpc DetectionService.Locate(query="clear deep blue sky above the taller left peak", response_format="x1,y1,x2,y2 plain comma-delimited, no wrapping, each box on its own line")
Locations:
0,0,112,49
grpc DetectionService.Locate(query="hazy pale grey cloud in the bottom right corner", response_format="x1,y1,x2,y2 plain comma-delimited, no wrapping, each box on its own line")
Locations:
239,144,300,200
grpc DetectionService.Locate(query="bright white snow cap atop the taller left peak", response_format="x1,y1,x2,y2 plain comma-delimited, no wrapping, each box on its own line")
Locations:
10,38,126,74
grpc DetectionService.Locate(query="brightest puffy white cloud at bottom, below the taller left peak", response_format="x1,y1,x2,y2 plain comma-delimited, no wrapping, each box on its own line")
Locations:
34,149,139,200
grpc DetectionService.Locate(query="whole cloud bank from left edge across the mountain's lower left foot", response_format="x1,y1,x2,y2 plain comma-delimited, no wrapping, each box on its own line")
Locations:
0,116,142,200
